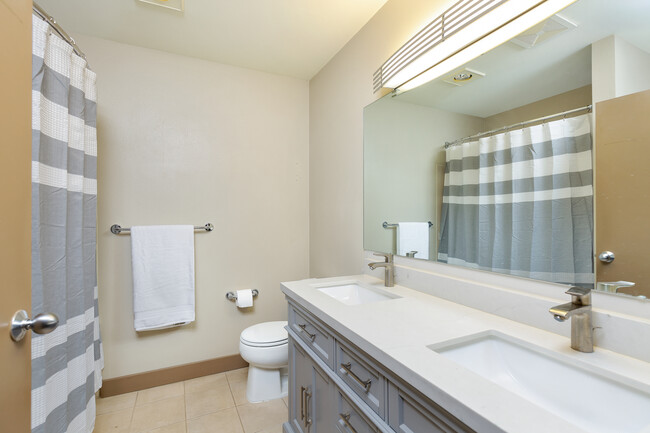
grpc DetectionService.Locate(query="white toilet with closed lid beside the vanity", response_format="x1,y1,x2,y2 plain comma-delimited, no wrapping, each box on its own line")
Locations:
239,321,289,403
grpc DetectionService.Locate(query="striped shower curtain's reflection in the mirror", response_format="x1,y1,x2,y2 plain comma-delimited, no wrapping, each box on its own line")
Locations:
438,114,594,287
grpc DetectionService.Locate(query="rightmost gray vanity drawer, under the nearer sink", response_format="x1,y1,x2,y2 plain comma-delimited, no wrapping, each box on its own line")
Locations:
388,383,473,433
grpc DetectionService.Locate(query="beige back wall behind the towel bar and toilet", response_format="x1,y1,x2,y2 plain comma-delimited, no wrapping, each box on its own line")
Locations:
75,35,309,379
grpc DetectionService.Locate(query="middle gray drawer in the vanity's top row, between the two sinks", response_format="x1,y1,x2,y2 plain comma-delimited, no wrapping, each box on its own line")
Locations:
336,342,386,418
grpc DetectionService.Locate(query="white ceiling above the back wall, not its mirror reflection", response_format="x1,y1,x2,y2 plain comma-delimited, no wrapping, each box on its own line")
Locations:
36,0,387,79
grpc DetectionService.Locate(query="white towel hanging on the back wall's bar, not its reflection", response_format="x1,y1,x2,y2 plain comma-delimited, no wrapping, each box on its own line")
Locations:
131,226,194,331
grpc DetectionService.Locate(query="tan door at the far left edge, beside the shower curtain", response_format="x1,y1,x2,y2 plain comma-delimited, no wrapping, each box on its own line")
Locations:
0,0,32,433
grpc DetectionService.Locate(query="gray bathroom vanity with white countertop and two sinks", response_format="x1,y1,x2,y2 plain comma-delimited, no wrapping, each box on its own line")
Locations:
282,275,650,433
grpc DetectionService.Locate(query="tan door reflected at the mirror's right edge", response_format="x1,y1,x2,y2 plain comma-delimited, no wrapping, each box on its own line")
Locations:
595,90,650,298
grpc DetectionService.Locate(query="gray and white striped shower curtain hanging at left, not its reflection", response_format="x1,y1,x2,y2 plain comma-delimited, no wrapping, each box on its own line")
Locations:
32,17,103,433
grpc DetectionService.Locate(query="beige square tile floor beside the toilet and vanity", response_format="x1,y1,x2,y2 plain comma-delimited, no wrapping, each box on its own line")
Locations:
93,368,288,433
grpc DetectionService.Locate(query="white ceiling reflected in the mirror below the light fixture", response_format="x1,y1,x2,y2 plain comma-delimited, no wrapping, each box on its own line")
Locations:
396,0,650,117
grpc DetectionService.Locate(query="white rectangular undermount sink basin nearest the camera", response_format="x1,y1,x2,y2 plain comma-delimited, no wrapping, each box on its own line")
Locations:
427,331,650,433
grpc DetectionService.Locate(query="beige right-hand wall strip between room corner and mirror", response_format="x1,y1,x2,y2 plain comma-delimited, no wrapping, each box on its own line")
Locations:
309,0,454,277
